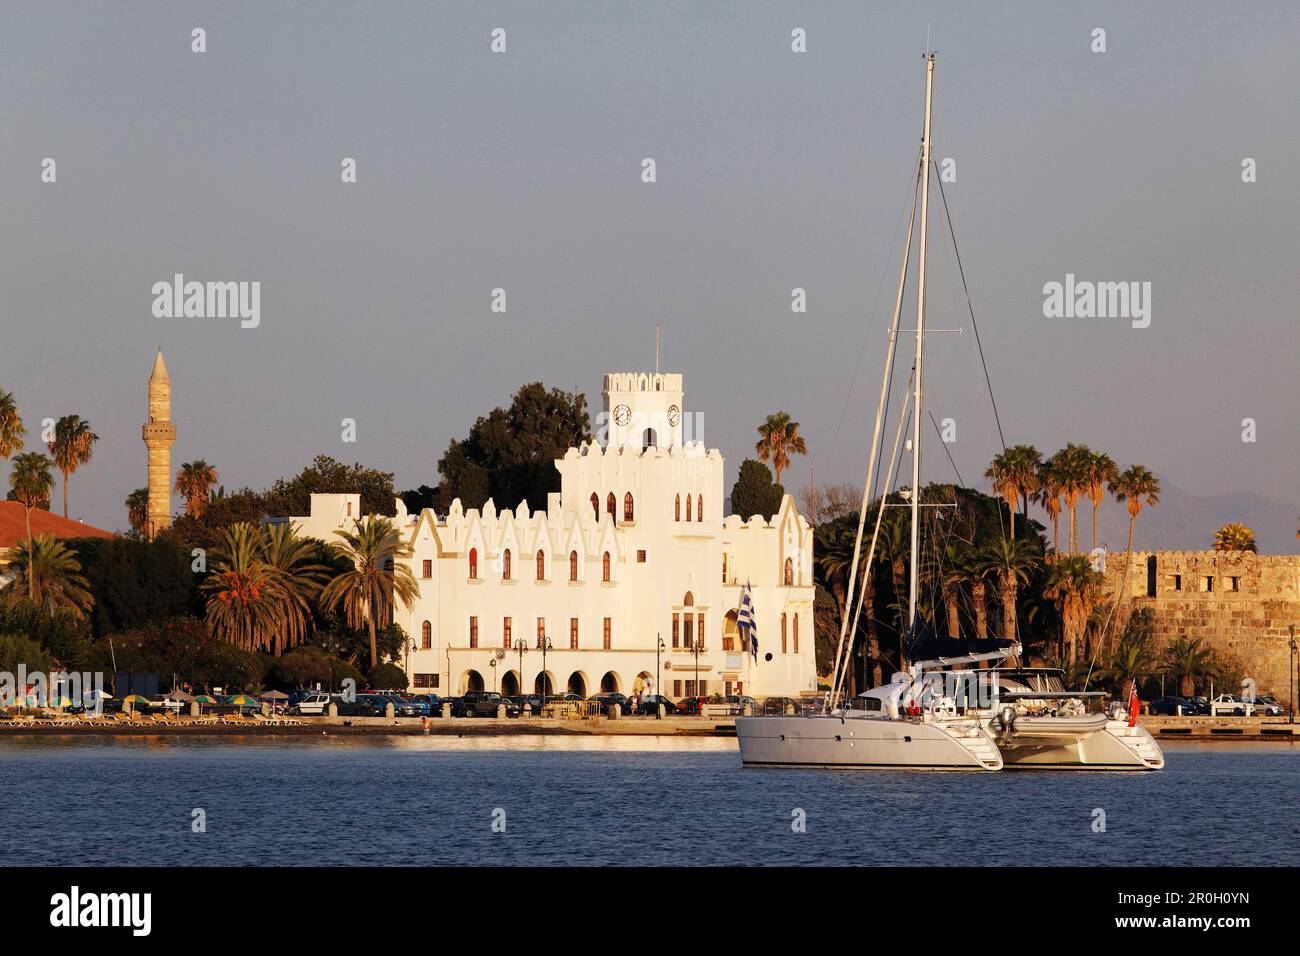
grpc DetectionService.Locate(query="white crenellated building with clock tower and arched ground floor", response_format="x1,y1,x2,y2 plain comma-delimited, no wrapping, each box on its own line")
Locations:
291,373,816,698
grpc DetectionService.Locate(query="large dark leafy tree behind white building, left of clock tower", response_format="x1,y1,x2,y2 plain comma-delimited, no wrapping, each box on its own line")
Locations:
434,382,592,512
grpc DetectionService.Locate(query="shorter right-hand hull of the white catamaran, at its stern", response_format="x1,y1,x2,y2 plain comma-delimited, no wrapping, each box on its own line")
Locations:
995,718,1165,770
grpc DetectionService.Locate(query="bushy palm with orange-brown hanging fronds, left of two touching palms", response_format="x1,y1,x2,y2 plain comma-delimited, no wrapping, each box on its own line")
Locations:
199,522,286,650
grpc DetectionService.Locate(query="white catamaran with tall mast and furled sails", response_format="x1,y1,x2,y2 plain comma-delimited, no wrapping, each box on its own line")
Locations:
736,52,1165,771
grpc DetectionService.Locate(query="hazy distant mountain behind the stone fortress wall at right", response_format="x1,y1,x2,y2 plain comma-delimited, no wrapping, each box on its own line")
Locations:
1086,481,1300,554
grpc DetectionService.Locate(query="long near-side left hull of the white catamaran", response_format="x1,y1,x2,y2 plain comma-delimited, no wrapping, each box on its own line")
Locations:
736,715,1002,770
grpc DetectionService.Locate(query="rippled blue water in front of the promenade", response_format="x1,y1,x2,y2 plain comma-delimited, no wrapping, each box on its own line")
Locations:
0,737,1300,866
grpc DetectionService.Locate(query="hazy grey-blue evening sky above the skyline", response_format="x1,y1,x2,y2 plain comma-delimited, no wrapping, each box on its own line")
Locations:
0,0,1300,550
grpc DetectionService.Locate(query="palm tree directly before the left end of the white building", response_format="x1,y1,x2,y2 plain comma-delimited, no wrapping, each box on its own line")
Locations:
321,515,420,670
